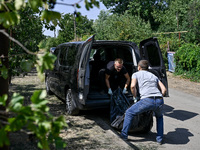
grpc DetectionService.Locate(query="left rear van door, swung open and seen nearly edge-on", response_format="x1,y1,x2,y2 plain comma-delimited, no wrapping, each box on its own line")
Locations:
77,35,95,104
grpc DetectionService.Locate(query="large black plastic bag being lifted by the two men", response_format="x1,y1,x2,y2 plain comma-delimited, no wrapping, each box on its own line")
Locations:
110,88,153,133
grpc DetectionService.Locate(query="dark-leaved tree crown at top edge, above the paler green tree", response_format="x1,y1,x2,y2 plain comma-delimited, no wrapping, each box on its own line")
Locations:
101,0,168,31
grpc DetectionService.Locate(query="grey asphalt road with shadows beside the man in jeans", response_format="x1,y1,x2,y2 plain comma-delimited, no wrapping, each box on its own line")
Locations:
127,87,200,150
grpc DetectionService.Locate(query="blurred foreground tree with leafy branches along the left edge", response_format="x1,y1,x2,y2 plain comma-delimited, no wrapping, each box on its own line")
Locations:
0,0,99,149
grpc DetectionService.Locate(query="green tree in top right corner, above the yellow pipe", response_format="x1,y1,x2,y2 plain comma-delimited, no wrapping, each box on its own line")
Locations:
153,0,200,43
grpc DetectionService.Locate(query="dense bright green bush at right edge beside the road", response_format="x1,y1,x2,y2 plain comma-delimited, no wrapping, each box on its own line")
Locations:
174,43,200,81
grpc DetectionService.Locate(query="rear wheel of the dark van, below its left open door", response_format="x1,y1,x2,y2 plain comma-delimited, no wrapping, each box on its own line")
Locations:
65,89,79,115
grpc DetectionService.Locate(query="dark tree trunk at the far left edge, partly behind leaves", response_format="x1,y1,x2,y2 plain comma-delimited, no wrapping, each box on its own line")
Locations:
0,25,9,150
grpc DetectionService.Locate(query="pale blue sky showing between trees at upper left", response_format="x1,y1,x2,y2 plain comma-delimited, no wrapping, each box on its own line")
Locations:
43,0,107,37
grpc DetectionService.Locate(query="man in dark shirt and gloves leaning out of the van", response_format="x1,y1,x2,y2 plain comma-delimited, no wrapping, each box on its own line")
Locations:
105,58,130,94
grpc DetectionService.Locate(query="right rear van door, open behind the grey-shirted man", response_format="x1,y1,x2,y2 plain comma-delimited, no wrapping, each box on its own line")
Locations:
140,38,169,97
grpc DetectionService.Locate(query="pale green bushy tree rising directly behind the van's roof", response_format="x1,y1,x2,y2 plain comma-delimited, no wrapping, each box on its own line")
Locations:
93,12,152,44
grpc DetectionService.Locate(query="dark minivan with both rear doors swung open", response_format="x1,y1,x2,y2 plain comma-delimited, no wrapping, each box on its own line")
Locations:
45,35,168,115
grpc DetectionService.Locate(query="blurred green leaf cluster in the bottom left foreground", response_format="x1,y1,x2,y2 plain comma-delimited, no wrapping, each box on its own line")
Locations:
0,90,66,150
